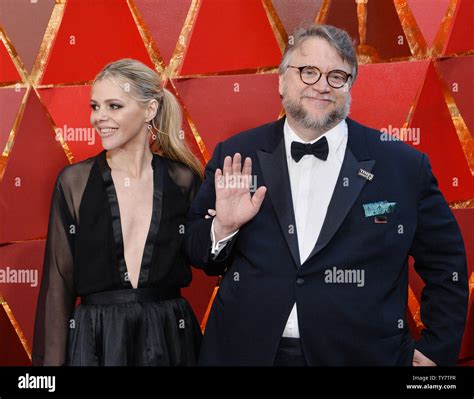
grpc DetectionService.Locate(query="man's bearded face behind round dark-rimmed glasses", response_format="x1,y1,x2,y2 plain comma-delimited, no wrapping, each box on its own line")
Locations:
279,38,352,130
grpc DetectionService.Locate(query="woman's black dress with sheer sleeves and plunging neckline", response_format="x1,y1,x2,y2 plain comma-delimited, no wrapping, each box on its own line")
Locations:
33,151,201,366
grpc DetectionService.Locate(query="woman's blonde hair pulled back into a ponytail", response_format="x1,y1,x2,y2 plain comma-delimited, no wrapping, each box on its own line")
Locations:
94,58,203,178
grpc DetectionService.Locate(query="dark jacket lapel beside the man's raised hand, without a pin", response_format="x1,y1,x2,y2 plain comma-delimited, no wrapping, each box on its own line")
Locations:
257,118,301,267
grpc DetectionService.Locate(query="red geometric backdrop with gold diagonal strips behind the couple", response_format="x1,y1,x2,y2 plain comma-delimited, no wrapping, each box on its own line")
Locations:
0,0,474,365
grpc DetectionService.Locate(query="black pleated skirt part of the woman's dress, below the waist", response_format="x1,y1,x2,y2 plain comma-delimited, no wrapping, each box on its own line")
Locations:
67,289,201,366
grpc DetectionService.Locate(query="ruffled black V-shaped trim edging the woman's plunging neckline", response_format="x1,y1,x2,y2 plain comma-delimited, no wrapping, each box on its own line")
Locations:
98,150,163,289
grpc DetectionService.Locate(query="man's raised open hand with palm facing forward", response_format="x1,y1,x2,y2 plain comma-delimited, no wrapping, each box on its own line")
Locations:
214,153,267,241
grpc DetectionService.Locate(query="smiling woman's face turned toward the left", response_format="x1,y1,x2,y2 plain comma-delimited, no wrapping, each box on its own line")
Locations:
90,78,156,150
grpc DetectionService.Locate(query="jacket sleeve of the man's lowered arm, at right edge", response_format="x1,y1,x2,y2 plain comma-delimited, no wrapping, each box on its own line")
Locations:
410,155,469,366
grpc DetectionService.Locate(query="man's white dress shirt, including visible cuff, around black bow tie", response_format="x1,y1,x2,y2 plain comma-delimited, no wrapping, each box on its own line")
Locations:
211,120,347,338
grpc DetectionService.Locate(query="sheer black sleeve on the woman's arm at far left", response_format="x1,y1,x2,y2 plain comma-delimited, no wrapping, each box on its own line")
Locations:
32,166,83,366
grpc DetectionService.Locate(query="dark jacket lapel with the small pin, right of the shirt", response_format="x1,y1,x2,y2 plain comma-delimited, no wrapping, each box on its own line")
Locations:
305,119,375,263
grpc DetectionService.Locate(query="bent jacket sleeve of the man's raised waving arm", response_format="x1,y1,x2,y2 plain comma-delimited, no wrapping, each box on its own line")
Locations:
185,143,238,276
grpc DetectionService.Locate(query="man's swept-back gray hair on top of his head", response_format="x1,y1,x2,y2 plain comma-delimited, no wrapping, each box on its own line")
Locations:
278,25,358,86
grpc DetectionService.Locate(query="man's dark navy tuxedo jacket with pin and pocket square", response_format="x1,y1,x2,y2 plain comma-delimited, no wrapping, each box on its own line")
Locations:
185,119,468,366
